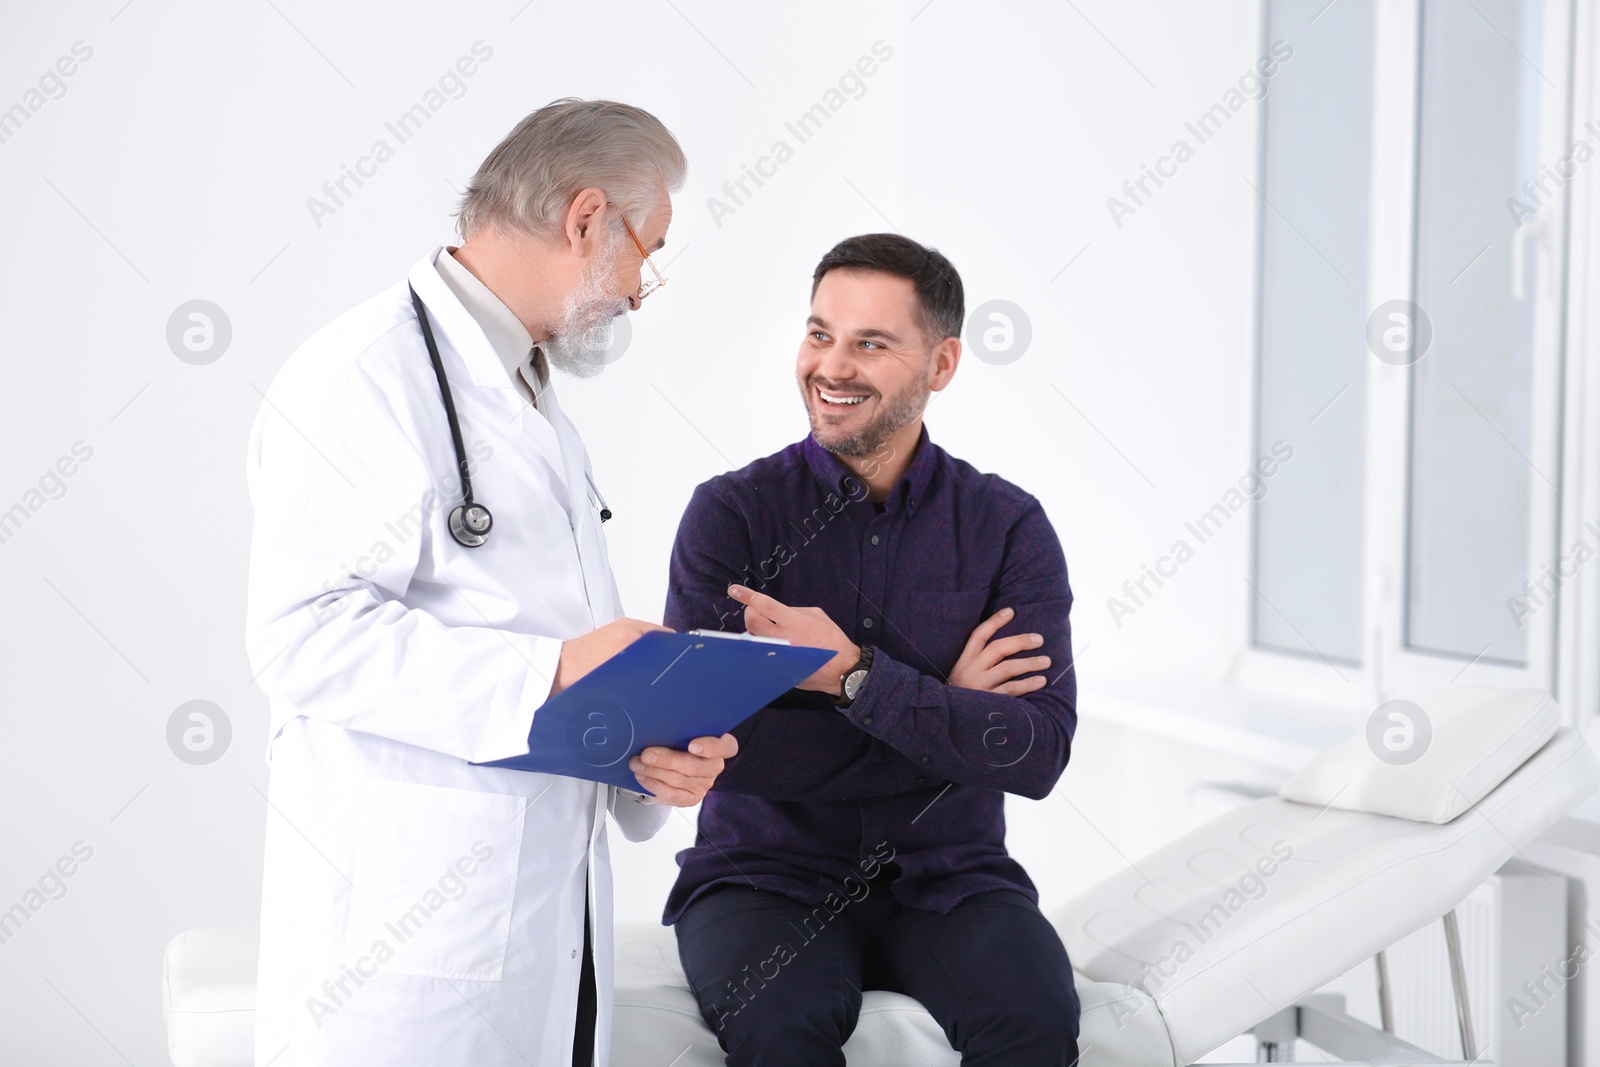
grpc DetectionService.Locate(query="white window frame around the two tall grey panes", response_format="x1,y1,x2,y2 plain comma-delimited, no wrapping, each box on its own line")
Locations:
1229,0,1600,728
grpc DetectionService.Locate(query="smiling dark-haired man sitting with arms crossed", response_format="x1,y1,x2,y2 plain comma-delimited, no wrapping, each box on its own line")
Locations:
664,234,1078,1067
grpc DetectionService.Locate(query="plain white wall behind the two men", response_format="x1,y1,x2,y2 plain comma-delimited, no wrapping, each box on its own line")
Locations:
0,0,1259,1065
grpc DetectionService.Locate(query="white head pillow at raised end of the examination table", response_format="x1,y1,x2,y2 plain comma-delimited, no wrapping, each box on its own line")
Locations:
1278,686,1562,824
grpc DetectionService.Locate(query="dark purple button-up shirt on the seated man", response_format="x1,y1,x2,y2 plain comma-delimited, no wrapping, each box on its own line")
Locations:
662,427,1077,925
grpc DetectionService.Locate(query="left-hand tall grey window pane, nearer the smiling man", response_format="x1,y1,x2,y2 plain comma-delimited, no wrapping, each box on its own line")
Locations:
1251,0,1373,662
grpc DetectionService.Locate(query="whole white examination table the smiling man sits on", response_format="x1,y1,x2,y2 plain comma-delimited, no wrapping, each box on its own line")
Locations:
163,686,1600,1067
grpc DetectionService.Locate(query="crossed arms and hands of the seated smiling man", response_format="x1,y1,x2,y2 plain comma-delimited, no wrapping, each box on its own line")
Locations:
649,483,1077,800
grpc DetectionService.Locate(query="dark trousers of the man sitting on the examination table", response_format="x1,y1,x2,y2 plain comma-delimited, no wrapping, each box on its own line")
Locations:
677,864,1078,1067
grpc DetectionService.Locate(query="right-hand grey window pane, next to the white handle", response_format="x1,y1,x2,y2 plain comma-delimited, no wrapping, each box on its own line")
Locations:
1405,0,1566,665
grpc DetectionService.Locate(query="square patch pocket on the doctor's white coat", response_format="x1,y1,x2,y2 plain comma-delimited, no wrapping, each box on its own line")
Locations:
346,781,526,982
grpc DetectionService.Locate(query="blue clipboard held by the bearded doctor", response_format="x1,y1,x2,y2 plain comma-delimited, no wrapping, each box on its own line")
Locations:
478,630,834,793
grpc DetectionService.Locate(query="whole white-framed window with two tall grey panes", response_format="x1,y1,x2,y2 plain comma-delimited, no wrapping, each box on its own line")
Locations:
1237,0,1574,705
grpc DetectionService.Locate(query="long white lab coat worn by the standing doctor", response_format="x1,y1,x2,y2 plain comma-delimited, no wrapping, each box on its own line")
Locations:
246,250,669,1067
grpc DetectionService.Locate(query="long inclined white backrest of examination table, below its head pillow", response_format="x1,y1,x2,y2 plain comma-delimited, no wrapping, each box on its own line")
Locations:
1050,728,1600,1064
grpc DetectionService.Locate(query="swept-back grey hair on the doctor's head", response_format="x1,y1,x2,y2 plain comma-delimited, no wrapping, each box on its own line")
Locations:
456,96,688,238
